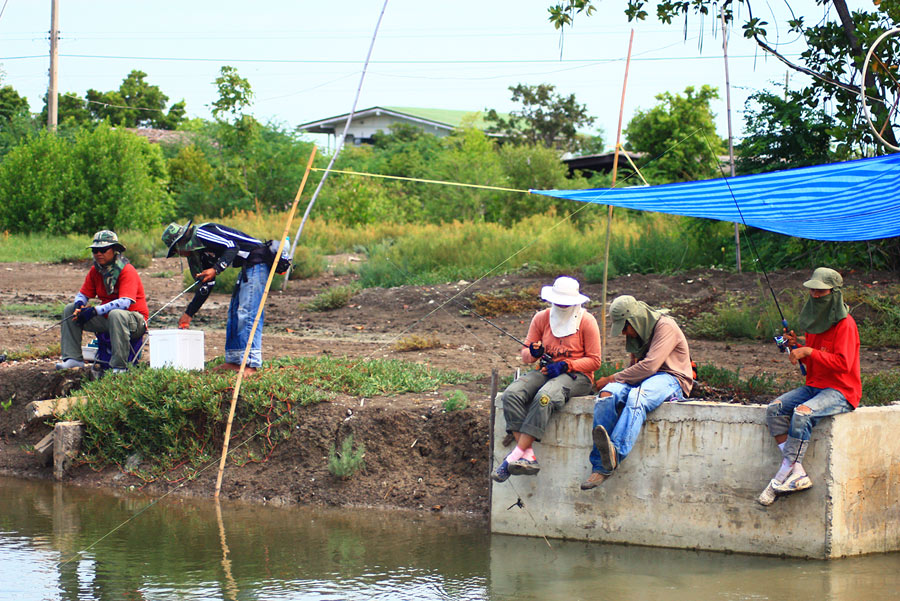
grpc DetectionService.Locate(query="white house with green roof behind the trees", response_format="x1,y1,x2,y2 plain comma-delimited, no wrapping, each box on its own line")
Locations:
297,106,508,144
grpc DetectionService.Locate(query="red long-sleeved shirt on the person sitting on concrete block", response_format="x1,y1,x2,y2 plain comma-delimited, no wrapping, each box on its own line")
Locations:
803,315,862,408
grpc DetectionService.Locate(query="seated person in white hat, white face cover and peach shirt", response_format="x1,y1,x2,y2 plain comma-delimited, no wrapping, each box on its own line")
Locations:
491,276,600,482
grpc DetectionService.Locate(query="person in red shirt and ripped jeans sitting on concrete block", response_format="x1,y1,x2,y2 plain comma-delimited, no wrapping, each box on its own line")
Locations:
757,267,862,505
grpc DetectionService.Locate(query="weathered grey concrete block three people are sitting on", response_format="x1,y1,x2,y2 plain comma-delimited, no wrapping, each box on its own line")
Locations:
491,395,900,558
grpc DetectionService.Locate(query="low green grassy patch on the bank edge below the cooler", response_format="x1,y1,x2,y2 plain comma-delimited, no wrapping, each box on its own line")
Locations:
63,357,473,481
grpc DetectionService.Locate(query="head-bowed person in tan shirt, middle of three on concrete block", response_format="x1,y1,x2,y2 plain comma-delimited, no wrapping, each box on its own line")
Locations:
581,295,694,490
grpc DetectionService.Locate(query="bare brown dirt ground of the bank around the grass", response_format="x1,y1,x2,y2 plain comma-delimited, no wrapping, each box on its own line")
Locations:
0,255,900,515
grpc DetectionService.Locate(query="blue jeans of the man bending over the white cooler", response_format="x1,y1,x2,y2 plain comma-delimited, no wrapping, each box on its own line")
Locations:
225,263,269,367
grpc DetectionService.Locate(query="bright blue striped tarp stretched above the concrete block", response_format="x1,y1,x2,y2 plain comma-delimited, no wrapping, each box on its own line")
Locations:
531,154,900,241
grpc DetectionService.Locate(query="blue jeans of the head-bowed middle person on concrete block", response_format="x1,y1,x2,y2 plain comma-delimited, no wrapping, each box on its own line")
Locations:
591,373,684,474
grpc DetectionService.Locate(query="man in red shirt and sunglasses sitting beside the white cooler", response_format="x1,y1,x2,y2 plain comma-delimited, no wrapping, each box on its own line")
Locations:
56,230,149,373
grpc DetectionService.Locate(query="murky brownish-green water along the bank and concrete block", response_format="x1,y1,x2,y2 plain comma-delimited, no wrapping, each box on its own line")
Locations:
0,478,900,601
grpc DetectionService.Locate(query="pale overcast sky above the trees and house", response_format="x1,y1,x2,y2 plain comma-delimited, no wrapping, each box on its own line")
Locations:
0,0,860,145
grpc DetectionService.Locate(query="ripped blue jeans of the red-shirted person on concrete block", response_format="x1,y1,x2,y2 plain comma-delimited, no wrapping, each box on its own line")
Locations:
766,386,853,441
